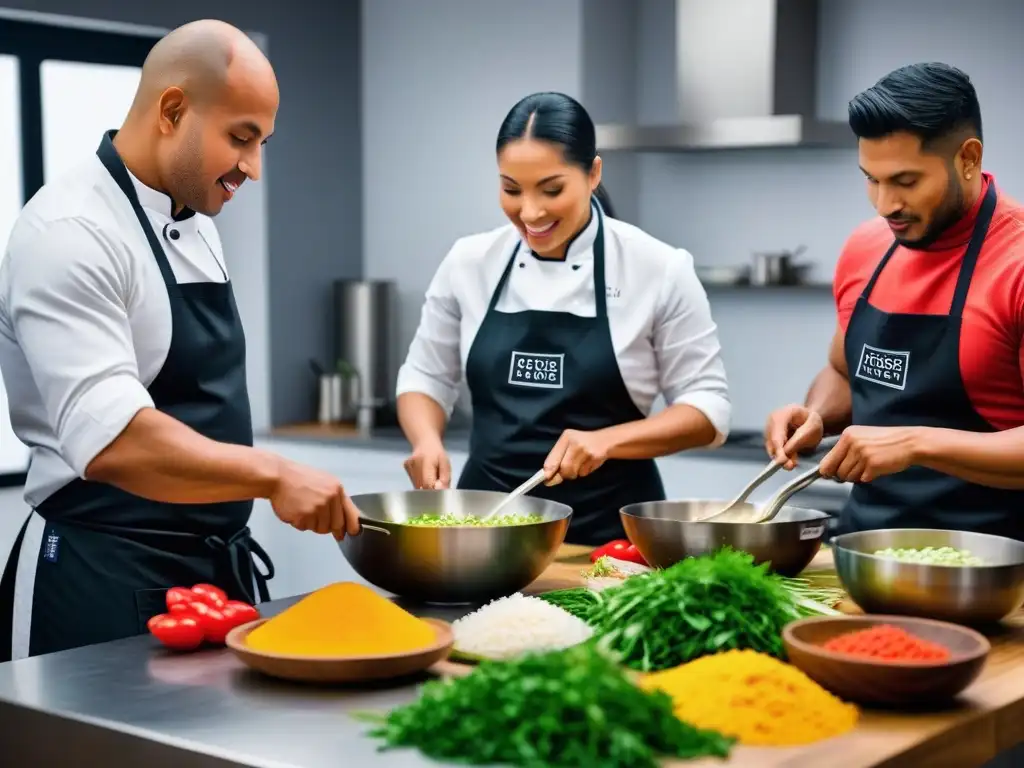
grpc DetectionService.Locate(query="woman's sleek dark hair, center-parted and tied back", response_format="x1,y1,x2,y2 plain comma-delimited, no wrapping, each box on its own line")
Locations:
496,91,615,218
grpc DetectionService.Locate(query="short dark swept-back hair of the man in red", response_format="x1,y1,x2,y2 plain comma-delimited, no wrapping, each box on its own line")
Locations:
849,62,981,148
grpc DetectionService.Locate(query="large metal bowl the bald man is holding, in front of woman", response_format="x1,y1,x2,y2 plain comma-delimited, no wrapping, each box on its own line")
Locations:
339,490,572,603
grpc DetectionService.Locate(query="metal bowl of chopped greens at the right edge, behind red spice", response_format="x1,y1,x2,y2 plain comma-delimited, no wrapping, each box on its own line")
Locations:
831,528,1024,624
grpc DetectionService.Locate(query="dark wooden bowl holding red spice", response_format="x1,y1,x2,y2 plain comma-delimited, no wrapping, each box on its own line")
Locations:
782,614,991,706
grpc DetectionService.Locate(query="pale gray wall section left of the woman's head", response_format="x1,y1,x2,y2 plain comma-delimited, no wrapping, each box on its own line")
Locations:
362,0,584,415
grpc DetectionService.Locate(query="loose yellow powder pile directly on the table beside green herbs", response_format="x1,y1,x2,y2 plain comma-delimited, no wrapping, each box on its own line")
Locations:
639,650,857,746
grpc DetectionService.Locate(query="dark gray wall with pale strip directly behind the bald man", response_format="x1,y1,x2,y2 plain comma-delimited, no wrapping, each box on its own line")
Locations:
0,0,362,429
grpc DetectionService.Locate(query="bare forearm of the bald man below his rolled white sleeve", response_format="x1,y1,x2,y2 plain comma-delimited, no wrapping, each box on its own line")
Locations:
85,408,282,504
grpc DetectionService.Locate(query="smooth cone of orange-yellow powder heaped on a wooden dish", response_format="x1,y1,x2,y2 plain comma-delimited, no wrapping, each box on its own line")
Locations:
246,582,437,657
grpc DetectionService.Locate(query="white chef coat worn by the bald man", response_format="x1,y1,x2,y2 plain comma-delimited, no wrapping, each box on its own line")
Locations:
0,156,227,506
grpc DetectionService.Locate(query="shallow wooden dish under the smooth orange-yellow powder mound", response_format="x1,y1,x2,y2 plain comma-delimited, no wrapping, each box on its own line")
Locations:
230,618,455,683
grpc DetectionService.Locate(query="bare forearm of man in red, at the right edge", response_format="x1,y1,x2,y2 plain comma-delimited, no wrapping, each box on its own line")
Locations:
912,427,1024,489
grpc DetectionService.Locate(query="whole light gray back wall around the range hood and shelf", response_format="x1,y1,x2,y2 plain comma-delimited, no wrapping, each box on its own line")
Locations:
362,0,1024,429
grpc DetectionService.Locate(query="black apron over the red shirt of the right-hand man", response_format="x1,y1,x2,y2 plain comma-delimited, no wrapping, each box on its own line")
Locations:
840,184,1024,539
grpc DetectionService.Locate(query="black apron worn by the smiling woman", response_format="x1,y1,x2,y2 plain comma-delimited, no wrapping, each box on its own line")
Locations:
458,201,665,546
